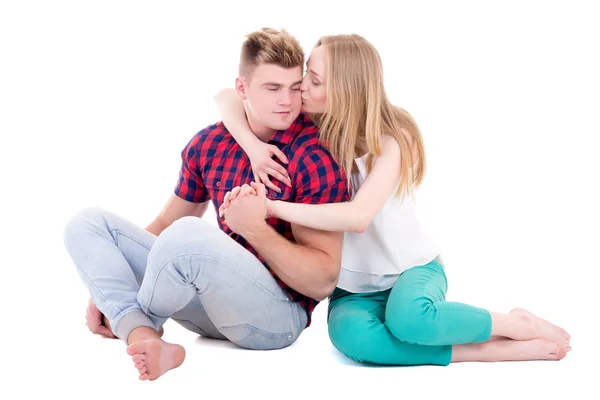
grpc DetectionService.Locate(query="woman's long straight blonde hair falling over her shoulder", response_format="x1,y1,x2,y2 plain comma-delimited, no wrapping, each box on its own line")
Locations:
311,35,425,196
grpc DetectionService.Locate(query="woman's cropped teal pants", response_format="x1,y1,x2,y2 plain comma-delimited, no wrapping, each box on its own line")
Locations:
327,260,492,365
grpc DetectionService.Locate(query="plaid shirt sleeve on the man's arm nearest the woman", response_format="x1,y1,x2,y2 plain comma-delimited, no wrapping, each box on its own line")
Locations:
294,146,350,204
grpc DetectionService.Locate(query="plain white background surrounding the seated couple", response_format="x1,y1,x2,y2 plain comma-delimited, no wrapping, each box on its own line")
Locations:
0,0,600,399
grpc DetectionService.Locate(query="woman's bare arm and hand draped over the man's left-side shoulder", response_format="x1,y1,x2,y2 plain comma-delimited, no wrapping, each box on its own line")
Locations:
215,89,292,193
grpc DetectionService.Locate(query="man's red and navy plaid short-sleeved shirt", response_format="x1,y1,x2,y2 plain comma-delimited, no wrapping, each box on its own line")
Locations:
175,113,350,326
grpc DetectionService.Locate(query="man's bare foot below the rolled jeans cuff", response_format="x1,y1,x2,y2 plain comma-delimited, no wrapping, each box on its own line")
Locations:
127,339,185,381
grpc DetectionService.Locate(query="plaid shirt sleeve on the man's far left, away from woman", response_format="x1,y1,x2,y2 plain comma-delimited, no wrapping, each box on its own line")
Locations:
175,135,210,203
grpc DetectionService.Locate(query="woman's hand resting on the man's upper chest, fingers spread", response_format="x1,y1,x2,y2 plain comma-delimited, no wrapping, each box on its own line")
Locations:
248,140,292,193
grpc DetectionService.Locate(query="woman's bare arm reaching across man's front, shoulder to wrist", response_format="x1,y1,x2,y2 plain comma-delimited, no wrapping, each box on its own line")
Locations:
269,135,400,232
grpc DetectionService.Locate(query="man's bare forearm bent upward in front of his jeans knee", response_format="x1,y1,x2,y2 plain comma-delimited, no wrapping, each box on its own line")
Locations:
243,223,339,301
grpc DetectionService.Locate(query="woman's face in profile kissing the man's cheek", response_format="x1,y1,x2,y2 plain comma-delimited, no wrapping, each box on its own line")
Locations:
300,46,327,114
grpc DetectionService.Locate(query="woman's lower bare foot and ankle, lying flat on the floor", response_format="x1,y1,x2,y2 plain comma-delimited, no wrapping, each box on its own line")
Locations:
452,339,567,362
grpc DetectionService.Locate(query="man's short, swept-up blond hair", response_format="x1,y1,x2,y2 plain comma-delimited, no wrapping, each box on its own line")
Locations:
239,28,304,79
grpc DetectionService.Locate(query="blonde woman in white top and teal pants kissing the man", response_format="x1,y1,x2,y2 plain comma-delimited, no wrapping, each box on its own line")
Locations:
216,35,571,365
